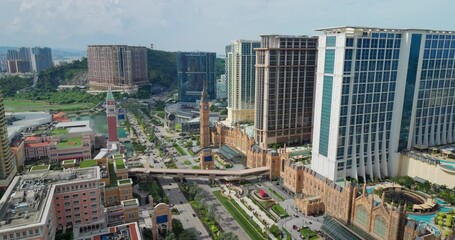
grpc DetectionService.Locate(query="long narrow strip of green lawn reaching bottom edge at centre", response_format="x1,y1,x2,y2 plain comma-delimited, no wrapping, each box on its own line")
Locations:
213,191,269,240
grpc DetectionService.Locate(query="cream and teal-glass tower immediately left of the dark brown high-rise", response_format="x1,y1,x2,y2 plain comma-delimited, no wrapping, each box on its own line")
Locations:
226,40,261,124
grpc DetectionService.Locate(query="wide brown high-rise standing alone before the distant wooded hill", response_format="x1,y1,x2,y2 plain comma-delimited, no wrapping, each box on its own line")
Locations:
87,45,150,93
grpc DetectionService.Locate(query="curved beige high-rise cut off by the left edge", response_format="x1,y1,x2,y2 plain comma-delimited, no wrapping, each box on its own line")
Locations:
0,93,17,187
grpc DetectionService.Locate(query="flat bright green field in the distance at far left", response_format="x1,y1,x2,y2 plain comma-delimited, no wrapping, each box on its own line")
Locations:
3,99,94,112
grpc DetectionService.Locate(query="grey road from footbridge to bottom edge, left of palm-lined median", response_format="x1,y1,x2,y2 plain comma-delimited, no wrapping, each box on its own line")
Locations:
158,178,212,240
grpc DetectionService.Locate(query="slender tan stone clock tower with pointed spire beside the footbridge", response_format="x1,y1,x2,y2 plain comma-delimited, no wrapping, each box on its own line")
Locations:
199,81,215,169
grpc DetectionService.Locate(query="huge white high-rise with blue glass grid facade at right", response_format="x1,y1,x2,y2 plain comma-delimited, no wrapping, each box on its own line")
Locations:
311,27,455,180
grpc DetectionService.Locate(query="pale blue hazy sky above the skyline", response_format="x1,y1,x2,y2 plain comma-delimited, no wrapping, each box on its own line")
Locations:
0,0,455,55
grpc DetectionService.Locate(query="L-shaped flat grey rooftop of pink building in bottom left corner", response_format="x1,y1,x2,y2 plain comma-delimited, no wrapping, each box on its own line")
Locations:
0,167,100,234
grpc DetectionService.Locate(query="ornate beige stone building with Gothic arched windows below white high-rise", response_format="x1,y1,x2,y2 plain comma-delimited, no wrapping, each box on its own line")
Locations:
281,154,436,240
